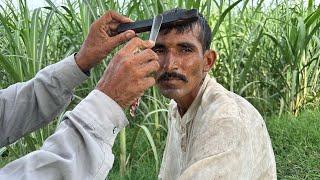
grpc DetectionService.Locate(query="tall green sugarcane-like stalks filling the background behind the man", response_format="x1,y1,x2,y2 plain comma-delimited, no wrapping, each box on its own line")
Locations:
0,0,320,176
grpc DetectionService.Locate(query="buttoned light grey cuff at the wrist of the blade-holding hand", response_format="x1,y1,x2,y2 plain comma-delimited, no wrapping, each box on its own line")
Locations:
67,90,129,145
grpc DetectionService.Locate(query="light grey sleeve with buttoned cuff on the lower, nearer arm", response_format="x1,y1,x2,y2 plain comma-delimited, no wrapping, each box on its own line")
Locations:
0,90,128,179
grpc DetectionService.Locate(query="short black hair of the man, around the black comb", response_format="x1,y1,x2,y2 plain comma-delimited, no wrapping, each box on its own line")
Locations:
161,8,212,52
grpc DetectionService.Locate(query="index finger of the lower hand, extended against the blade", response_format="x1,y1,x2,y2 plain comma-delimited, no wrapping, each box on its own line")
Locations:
119,37,154,54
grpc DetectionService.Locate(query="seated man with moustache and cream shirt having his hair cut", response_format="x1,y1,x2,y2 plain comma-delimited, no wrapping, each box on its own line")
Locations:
153,9,276,180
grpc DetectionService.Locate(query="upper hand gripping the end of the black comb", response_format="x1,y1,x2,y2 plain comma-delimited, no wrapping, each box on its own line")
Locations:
75,11,135,71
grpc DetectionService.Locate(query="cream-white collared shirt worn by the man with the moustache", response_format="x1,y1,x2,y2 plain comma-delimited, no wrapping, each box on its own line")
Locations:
159,75,276,180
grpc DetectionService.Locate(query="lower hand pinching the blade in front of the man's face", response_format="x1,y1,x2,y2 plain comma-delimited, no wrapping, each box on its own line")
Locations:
96,38,160,108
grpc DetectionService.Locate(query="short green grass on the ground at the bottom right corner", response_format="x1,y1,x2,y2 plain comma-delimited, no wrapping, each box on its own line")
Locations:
267,108,320,179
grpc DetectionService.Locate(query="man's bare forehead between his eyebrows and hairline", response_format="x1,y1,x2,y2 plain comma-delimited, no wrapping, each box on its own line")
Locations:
156,25,202,49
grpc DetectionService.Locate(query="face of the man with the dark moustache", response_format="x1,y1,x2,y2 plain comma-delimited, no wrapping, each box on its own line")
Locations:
153,26,211,99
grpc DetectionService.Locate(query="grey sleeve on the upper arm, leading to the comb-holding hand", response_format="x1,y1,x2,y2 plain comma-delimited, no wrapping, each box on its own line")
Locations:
0,55,88,147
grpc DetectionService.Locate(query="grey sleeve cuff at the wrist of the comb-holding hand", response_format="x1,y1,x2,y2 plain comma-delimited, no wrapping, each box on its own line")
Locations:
54,54,89,89
